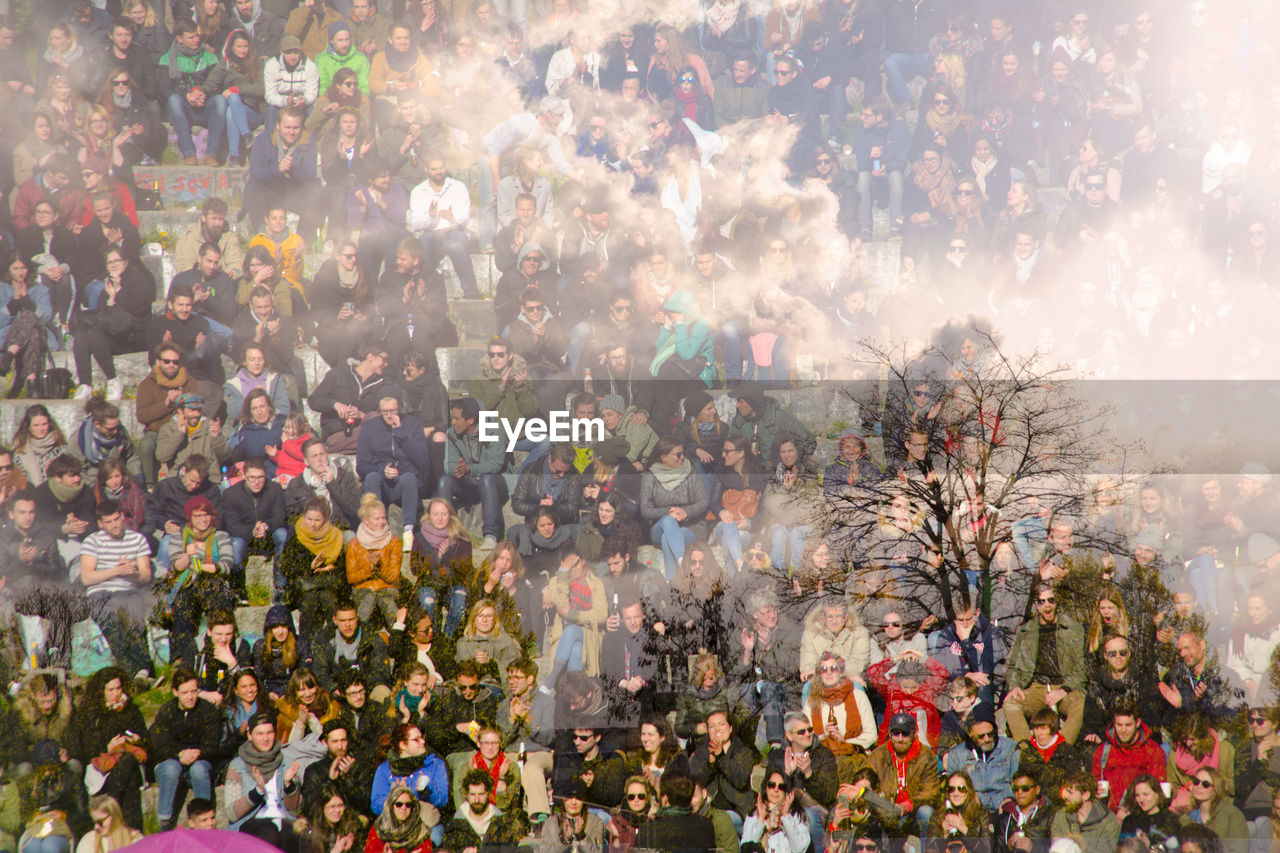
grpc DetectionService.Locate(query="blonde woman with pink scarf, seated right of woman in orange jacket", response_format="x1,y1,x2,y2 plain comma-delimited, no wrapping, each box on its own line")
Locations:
410,497,475,637
